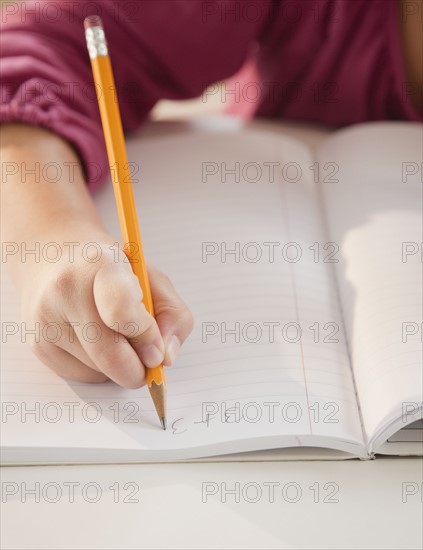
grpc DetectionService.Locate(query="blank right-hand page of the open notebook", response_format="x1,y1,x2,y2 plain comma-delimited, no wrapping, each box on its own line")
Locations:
318,123,422,452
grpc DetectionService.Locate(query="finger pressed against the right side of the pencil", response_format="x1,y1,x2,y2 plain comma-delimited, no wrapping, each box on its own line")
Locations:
148,266,194,365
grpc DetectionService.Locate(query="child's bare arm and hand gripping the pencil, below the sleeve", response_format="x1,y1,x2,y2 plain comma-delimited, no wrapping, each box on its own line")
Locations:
1,124,192,388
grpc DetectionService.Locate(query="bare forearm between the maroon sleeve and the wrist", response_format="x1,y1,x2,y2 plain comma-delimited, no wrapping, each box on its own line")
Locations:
0,124,106,286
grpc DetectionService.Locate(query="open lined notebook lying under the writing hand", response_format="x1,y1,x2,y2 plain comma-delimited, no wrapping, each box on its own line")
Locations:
2,123,423,463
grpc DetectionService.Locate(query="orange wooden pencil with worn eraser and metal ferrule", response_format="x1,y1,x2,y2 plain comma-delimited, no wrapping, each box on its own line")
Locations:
84,15,166,430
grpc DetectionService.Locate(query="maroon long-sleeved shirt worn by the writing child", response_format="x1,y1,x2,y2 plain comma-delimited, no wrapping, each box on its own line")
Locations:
0,0,421,188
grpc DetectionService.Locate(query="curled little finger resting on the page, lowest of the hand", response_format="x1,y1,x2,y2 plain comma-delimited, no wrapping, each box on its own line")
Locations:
33,342,109,384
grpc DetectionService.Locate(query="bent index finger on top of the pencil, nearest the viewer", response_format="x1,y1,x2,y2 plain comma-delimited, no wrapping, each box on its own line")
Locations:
93,263,165,367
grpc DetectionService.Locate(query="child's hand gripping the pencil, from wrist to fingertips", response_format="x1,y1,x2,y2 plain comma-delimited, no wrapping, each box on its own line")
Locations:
18,233,193,388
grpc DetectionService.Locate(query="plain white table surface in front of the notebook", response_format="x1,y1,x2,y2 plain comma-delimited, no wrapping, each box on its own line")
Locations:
0,119,423,550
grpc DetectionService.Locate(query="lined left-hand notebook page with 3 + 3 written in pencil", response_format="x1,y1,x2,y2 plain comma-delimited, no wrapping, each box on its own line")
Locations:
3,126,363,460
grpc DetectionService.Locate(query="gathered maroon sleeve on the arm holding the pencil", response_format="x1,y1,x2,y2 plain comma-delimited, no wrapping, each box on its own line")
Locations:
0,0,271,186
